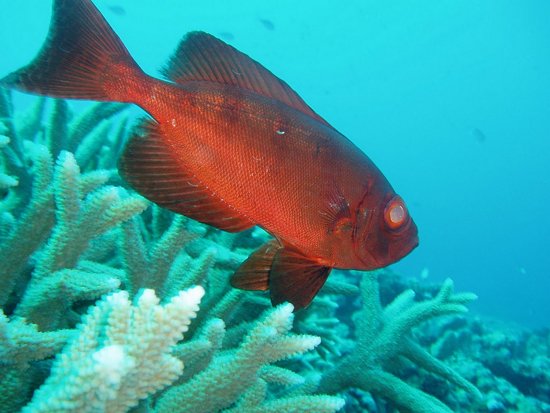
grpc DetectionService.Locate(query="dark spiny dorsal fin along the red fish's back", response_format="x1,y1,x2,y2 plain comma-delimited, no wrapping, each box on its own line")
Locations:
161,32,331,127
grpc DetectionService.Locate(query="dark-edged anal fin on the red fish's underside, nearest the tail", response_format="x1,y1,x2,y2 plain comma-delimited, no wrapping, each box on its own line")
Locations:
119,120,254,232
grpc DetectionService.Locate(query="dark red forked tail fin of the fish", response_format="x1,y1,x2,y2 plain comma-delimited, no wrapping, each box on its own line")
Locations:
0,0,143,102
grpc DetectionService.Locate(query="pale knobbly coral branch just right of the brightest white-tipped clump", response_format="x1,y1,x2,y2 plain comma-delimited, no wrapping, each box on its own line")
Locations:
155,303,344,413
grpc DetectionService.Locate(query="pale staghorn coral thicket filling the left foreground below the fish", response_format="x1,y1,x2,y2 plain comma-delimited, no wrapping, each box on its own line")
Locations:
0,91,350,412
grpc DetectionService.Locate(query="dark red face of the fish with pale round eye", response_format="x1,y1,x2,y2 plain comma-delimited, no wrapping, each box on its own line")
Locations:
353,183,418,270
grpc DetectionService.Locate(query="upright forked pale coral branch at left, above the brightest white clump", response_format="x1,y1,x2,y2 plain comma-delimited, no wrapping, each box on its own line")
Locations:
12,151,147,330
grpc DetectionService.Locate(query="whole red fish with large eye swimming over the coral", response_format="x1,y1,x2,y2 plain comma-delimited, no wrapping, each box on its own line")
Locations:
1,0,418,308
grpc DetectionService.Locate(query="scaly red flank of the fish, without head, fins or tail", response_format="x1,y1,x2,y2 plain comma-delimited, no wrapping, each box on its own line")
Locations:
134,79,385,268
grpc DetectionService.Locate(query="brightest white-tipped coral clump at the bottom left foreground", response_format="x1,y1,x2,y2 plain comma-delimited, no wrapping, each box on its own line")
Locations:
23,287,204,413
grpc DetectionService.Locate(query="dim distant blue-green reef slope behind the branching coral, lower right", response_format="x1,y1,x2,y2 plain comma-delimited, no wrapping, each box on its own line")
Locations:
358,271,550,413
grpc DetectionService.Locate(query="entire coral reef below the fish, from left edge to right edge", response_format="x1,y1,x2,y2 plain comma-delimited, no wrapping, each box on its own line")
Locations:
0,91,550,413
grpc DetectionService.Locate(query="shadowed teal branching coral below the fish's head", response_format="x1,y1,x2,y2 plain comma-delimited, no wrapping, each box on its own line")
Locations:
319,272,481,413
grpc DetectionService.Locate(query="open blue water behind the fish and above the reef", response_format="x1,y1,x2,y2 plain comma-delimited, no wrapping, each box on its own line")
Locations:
0,0,550,327
